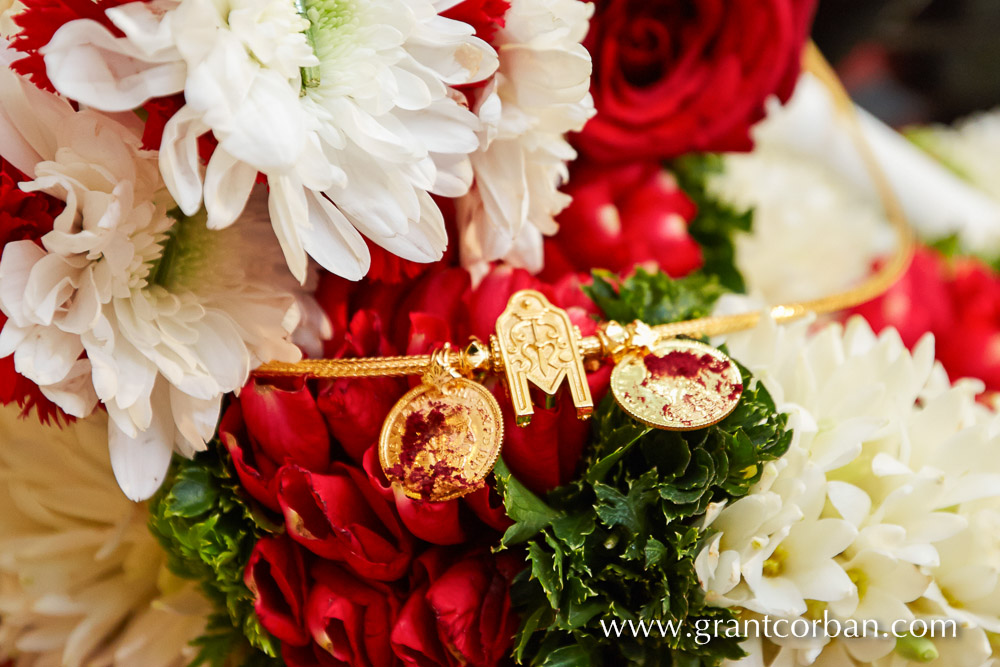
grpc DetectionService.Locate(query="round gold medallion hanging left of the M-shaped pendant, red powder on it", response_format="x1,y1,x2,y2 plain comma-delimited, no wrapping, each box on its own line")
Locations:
379,377,503,501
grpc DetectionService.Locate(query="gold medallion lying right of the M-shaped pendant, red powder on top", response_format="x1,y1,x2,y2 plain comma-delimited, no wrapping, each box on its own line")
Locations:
611,338,743,431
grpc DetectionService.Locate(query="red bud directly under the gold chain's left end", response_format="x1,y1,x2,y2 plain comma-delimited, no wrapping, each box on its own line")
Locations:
219,379,330,511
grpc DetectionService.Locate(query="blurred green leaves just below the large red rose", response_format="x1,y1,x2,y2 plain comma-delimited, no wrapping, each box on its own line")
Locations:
670,153,753,292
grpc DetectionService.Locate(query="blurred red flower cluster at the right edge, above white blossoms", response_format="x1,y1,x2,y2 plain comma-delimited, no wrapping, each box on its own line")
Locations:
854,248,1000,392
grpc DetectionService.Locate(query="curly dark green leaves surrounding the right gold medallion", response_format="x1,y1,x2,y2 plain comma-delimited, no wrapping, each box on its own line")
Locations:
504,273,791,667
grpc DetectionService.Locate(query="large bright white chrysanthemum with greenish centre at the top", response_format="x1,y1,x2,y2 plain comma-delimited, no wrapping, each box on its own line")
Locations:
44,0,497,280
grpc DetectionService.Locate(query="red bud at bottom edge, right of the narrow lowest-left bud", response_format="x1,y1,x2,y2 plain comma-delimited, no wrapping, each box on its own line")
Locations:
303,562,400,667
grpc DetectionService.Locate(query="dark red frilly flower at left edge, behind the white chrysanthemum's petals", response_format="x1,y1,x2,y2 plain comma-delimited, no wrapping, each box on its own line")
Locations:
0,158,72,423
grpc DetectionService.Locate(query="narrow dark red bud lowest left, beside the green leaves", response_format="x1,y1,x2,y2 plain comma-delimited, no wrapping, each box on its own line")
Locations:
243,535,310,646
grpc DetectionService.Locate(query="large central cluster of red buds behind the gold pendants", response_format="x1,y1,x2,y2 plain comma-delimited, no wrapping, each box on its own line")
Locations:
233,265,607,667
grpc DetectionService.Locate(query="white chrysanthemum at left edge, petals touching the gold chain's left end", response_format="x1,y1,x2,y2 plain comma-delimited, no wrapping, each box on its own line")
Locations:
0,70,312,499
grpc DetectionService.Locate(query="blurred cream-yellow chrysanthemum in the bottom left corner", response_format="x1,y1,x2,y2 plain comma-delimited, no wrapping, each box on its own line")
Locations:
0,406,211,667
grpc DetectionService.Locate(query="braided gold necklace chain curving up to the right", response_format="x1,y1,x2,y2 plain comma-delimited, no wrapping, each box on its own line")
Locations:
254,42,916,378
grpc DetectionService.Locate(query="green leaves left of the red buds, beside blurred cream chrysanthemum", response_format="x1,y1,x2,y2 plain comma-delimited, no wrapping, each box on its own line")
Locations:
149,443,282,667
